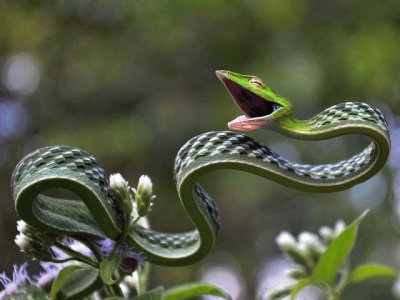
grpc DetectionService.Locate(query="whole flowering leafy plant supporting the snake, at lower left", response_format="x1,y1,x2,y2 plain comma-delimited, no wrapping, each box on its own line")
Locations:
0,174,231,300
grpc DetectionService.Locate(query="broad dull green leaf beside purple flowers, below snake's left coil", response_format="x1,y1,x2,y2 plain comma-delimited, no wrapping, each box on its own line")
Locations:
50,265,102,300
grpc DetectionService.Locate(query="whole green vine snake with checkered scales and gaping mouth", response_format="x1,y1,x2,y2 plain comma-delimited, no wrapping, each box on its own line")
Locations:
11,71,390,266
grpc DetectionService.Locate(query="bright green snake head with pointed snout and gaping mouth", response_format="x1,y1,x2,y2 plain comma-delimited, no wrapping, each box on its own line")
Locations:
215,70,292,131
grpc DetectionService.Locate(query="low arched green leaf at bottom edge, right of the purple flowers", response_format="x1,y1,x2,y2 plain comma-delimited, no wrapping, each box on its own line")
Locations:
162,283,232,300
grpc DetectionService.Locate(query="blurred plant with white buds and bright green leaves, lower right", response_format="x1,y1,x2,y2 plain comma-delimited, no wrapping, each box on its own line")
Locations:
264,211,397,300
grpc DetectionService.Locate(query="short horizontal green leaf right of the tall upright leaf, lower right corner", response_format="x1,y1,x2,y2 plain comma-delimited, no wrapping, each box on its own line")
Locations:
349,263,397,283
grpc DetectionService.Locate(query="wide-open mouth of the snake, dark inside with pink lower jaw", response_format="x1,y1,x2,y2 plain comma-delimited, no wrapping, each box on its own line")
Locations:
216,71,281,131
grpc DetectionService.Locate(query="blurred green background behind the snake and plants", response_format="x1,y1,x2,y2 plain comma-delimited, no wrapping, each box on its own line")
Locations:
0,0,400,299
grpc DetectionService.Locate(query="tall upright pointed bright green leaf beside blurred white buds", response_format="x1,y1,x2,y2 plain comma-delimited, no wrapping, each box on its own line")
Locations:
312,211,368,287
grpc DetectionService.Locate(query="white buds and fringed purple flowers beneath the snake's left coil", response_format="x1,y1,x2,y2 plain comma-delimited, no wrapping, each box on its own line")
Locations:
0,174,155,300
